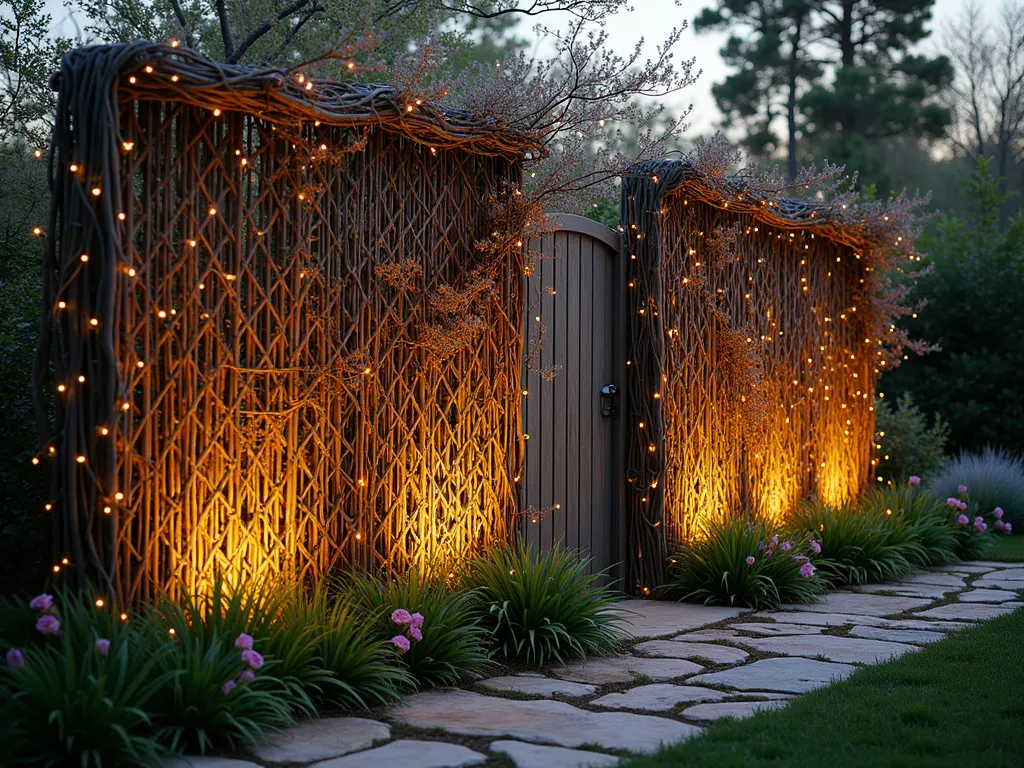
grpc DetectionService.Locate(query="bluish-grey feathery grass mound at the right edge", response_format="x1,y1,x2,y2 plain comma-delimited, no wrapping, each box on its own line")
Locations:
928,446,1024,532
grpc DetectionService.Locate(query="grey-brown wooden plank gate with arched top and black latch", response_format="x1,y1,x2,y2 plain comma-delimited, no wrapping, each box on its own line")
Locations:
520,214,628,586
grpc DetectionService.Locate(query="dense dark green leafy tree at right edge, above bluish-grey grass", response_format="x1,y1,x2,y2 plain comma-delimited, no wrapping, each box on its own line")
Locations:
880,158,1024,451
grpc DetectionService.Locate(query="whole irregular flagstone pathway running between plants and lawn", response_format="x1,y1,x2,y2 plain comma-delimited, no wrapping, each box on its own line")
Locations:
168,562,1024,768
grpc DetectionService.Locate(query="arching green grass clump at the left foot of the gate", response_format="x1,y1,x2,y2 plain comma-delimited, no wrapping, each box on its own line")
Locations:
466,539,626,667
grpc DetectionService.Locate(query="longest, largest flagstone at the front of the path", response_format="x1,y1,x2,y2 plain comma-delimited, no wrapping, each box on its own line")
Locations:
387,690,700,760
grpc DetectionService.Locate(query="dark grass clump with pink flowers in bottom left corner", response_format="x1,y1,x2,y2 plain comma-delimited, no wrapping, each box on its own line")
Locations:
0,591,174,768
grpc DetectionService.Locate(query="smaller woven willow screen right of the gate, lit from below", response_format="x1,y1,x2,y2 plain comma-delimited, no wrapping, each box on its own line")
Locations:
623,161,878,591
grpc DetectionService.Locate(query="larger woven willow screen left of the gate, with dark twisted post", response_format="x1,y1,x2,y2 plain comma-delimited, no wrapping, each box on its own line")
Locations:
40,44,525,602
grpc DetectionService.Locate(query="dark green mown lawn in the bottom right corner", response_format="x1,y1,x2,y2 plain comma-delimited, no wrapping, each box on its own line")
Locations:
625,610,1024,768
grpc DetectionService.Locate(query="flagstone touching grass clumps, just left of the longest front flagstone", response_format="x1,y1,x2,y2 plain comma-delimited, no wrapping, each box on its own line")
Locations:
249,718,391,763
